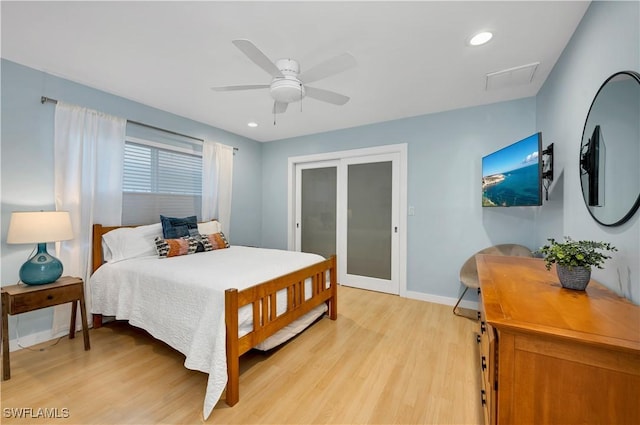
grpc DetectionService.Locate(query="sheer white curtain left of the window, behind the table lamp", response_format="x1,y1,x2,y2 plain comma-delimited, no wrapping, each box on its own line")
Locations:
53,102,127,335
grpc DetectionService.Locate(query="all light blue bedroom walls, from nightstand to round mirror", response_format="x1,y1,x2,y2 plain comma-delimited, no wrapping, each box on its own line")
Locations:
0,2,640,344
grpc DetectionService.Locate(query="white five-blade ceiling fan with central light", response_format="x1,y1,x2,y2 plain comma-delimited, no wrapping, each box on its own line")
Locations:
211,40,356,114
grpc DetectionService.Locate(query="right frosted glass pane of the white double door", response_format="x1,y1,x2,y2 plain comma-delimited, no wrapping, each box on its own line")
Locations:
347,161,392,279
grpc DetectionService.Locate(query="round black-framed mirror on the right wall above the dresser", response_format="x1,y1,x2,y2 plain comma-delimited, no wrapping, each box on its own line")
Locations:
580,71,640,226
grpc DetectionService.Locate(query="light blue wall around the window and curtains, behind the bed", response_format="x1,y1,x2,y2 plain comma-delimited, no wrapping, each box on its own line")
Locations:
0,59,263,338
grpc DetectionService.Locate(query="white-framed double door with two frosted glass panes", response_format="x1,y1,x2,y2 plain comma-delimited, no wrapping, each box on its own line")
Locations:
291,146,404,294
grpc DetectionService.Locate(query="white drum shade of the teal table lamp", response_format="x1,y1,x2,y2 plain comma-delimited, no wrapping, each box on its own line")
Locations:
7,211,73,244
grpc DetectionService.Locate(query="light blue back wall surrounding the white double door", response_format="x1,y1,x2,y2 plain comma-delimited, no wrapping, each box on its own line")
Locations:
262,98,539,299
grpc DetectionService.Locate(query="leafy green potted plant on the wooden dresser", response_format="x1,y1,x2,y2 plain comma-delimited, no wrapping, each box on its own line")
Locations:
536,236,617,291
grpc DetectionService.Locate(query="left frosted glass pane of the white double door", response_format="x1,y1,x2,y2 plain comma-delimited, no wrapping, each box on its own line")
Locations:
300,167,338,258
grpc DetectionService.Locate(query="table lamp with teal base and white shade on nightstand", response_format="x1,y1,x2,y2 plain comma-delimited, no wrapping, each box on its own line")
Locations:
7,211,73,285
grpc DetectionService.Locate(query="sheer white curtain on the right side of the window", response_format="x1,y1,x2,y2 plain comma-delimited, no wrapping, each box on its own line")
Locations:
202,140,233,237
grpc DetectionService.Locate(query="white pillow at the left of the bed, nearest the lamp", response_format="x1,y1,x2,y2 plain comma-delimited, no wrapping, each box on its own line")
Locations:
102,223,162,263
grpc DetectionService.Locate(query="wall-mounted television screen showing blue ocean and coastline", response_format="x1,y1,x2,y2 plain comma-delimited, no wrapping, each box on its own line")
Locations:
482,133,542,207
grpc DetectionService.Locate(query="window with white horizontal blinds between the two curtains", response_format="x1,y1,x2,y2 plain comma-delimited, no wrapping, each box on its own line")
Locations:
122,137,202,225
